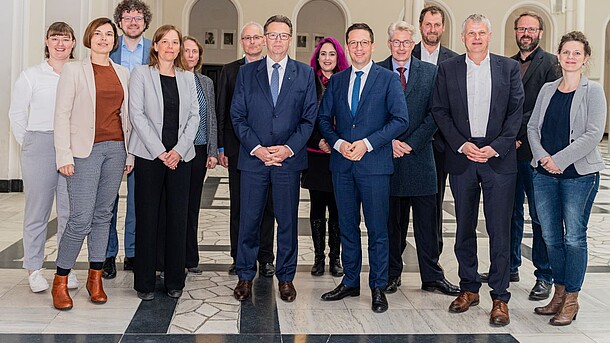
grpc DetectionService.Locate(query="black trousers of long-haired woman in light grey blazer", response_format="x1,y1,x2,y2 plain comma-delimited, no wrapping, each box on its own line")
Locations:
134,157,191,292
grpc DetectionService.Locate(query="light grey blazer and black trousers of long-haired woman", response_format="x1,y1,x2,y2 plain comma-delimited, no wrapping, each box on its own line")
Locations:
129,66,199,293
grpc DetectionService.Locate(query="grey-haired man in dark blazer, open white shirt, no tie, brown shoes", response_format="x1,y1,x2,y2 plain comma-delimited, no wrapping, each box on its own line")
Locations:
432,14,523,325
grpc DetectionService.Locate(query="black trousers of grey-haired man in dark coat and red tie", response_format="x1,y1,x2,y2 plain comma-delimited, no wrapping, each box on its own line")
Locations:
388,194,444,282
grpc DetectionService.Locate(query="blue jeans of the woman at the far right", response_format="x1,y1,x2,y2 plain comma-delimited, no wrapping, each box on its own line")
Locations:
534,172,599,292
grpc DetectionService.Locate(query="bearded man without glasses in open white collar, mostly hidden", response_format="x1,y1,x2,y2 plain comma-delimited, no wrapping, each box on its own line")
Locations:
413,5,457,252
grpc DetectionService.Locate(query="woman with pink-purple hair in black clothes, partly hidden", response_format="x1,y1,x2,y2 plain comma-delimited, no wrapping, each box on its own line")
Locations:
301,37,349,276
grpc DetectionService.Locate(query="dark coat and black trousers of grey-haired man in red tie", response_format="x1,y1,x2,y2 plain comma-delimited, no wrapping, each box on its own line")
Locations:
379,56,444,282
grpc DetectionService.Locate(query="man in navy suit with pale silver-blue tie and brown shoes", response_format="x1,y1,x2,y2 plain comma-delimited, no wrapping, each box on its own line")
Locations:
231,15,317,302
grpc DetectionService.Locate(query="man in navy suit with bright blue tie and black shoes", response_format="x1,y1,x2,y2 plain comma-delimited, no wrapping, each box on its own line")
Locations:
318,23,409,313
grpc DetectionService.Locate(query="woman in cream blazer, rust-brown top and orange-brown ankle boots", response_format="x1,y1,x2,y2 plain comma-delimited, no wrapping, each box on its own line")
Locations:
52,18,133,310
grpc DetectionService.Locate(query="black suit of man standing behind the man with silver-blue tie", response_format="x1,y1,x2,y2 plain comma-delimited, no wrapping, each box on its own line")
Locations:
216,57,275,263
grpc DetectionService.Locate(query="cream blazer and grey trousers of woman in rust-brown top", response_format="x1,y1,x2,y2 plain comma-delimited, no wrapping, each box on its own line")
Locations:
54,58,134,269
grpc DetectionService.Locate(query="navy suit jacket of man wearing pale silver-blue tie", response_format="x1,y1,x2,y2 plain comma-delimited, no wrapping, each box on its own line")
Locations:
231,58,317,172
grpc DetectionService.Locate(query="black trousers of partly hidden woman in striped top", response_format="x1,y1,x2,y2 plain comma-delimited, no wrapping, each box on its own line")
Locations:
186,145,208,268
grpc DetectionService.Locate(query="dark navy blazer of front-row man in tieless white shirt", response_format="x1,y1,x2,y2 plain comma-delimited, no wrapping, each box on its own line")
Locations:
432,53,524,175
